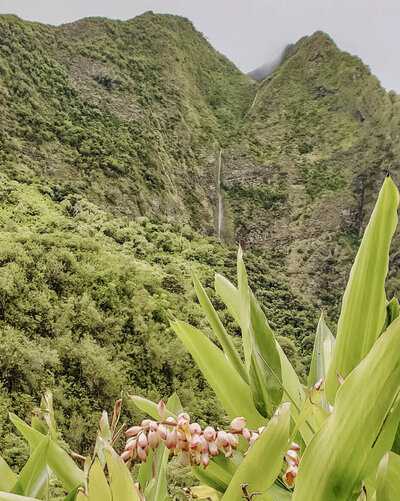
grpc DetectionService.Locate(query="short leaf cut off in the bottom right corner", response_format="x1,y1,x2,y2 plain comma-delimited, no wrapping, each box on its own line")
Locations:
376,452,400,501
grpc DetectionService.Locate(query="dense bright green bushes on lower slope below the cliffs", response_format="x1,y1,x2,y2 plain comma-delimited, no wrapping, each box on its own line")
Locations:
0,176,318,463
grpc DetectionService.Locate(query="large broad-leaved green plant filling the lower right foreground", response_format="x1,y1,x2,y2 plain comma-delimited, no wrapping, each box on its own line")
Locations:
126,176,400,501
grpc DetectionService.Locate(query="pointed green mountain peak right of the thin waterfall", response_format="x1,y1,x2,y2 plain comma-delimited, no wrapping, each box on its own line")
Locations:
223,32,400,310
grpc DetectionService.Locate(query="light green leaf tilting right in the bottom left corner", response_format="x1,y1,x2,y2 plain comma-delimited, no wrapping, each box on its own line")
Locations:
11,435,50,498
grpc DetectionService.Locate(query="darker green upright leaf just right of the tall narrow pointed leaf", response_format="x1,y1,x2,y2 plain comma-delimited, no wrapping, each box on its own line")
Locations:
249,294,283,417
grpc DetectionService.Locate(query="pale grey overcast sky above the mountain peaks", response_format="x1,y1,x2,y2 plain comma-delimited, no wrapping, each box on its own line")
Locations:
0,0,400,92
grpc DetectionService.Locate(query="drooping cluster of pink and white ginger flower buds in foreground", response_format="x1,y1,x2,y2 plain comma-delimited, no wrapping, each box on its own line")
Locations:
121,401,264,468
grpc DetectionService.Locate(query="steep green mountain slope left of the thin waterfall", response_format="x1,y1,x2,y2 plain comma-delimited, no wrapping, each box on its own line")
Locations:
0,13,254,233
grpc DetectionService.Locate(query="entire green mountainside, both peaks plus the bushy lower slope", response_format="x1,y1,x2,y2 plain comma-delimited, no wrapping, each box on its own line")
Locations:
0,13,400,474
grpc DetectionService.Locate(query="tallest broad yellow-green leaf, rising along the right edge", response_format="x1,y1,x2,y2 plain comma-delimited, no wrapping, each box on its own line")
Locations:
326,177,399,404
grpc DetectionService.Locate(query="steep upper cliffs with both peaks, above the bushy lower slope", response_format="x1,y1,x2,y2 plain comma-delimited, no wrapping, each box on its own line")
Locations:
0,13,400,314
